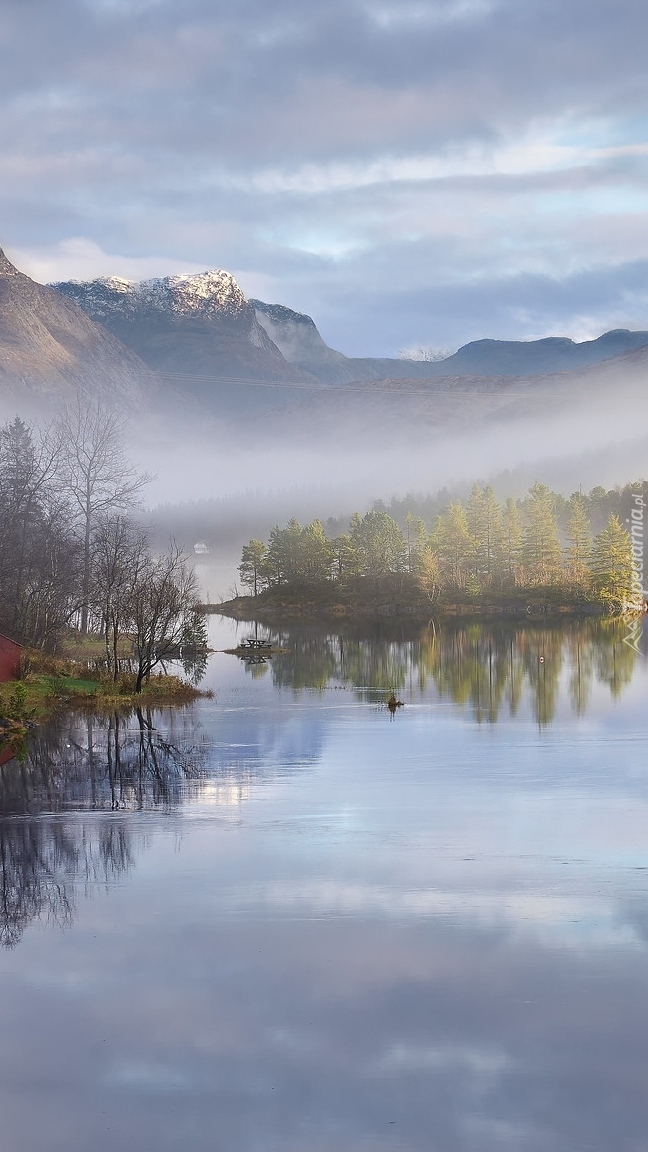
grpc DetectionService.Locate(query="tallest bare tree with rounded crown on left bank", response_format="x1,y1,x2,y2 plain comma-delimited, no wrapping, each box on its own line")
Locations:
56,396,150,632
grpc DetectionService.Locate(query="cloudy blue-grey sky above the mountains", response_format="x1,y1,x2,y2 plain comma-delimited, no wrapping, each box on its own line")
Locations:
0,0,648,355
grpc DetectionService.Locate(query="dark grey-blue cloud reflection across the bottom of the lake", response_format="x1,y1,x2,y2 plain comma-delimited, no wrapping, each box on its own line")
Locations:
0,903,646,1152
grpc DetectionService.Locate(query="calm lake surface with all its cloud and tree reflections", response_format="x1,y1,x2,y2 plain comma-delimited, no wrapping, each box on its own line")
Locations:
0,620,648,1152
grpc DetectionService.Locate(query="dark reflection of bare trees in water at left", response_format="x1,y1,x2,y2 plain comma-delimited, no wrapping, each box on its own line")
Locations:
0,711,203,947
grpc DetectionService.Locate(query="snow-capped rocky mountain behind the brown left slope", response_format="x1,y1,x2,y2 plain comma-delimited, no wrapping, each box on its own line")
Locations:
51,270,317,411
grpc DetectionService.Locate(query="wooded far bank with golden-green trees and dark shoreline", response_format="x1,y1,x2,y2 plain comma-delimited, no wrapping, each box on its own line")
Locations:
232,482,645,619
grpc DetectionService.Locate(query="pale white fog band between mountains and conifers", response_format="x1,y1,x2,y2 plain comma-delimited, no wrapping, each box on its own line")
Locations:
118,358,648,600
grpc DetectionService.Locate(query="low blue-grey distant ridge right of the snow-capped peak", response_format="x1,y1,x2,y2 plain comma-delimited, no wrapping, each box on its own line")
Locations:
250,300,648,384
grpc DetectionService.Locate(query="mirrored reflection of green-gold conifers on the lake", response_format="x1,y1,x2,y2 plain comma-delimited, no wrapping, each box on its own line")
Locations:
264,620,636,725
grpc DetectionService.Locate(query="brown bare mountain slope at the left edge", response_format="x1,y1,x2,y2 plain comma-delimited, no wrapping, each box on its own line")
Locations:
0,249,156,415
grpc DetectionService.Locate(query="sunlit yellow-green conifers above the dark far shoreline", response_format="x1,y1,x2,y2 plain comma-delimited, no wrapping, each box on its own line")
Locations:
239,483,643,608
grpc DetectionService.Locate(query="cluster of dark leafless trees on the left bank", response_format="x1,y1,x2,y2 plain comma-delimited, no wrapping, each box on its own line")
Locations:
0,401,204,690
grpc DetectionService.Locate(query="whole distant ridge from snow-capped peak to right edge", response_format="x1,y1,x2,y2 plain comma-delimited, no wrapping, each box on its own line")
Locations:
51,268,648,389
